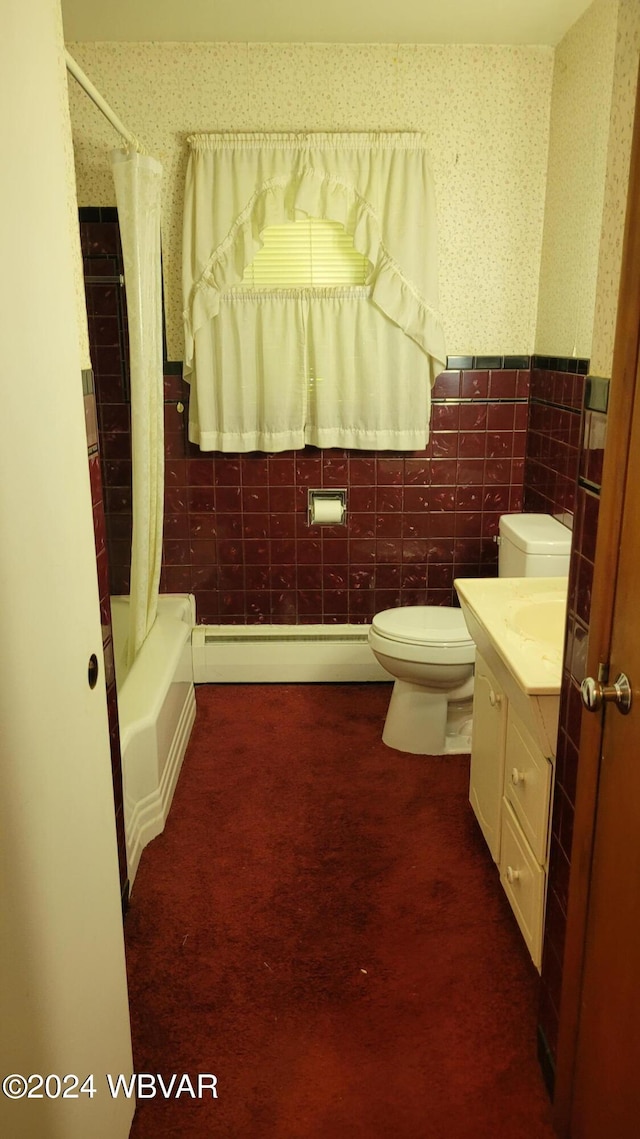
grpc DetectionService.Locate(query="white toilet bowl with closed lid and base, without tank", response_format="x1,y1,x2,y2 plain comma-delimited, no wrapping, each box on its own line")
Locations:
369,605,476,755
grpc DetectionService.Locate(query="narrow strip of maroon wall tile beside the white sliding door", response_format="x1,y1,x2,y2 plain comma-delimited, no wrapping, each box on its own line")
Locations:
82,369,129,912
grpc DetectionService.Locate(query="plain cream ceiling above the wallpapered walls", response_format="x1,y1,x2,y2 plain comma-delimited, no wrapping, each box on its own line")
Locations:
61,0,592,44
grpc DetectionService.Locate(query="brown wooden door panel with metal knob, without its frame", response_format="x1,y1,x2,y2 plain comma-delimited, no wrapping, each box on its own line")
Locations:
571,350,640,1139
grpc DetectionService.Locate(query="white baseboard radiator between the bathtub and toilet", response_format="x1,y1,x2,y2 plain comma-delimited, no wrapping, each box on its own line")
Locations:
191,625,391,685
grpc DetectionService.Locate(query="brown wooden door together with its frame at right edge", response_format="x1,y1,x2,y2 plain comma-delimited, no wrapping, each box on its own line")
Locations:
555,62,640,1139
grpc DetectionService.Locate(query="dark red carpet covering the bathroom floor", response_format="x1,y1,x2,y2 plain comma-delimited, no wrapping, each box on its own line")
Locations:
125,685,553,1139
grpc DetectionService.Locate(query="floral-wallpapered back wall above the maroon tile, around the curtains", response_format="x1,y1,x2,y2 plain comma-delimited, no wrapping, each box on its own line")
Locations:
69,43,551,360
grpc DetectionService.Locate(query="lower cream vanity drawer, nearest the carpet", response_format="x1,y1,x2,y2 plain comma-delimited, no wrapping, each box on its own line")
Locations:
500,800,545,972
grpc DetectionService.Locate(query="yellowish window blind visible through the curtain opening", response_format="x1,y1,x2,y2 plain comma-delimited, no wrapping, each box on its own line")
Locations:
238,218,371,289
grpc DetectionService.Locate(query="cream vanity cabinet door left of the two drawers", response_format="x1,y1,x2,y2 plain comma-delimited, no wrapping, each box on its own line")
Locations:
469,655,507,862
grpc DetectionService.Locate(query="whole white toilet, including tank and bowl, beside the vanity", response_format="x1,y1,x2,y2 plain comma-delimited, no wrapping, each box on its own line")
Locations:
369,514,572,755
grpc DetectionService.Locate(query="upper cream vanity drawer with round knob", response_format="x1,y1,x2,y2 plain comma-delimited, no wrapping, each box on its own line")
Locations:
504,705,553,865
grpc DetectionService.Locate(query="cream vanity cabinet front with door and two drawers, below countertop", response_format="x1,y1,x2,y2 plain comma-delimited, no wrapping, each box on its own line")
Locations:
469,656,555,969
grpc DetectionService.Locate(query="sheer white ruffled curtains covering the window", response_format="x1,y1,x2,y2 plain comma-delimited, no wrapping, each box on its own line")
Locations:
183,133,445,451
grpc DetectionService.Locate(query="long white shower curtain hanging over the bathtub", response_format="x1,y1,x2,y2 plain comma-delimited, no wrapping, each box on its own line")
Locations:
112,150,164,664
